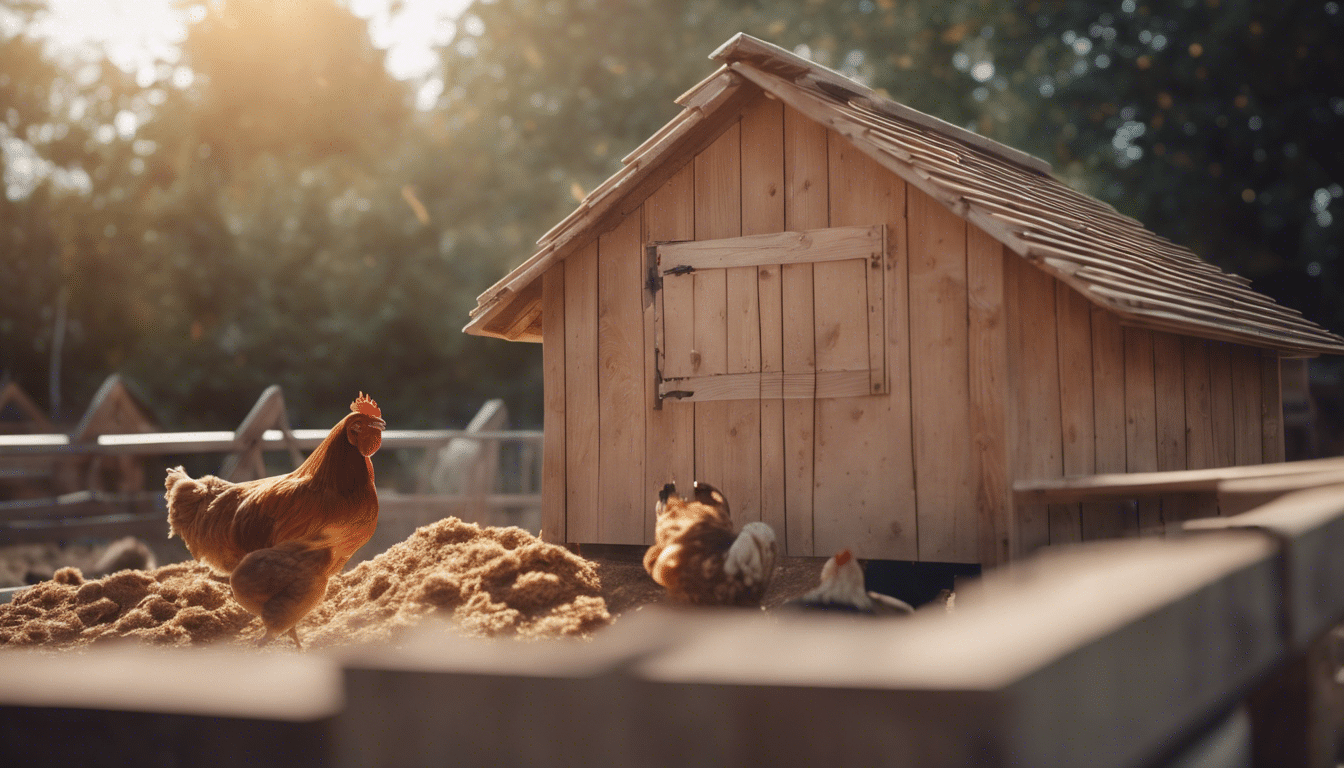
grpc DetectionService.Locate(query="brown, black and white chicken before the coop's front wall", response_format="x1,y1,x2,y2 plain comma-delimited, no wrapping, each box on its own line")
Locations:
644,483,778,607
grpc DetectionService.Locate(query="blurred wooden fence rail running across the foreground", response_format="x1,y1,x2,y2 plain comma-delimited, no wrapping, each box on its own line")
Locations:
0,487,1344,768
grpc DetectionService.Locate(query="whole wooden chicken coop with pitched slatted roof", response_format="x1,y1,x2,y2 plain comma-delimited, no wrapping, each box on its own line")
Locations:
465,35,1344,565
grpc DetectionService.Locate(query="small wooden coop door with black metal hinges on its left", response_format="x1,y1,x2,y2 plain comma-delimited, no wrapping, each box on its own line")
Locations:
649,225,887,401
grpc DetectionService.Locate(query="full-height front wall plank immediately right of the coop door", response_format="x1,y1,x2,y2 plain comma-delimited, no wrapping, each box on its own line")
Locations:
906,187,978,562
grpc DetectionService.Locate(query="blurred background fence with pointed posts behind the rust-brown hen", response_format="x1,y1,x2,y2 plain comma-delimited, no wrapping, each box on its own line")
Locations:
0,378,542,554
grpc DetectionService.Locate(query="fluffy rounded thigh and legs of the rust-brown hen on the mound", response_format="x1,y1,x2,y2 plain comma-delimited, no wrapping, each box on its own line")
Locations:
228,541,332,648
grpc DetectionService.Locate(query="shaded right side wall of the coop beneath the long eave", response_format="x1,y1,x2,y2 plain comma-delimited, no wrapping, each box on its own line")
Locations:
1004,253,1284,553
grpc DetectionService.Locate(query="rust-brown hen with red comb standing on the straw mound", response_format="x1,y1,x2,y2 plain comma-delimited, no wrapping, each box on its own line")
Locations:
164,393,387,647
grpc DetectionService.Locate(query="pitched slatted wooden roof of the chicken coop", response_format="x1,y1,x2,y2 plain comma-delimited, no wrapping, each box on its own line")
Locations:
464,34,1344,355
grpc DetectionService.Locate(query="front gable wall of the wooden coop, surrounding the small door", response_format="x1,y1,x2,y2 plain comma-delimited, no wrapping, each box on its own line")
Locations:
543,98,1026,562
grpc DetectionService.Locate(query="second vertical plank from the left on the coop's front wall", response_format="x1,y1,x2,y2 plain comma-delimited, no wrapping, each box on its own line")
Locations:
564,241,601,542
